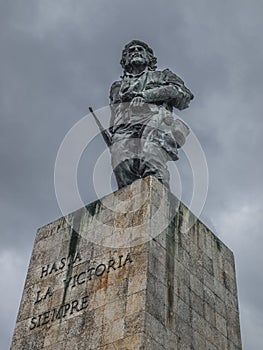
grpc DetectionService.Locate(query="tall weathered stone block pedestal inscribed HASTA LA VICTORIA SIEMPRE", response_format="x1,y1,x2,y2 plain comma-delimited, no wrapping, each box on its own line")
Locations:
11,177,241,350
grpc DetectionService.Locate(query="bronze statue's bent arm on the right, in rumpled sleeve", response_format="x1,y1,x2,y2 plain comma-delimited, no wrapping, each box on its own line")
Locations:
140,69,194,110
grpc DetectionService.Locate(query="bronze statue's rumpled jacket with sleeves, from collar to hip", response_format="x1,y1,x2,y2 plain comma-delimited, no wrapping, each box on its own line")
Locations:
109,69,193,159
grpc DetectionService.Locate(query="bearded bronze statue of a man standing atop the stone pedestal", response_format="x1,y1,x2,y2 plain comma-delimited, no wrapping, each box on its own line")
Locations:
109,40,193,188
